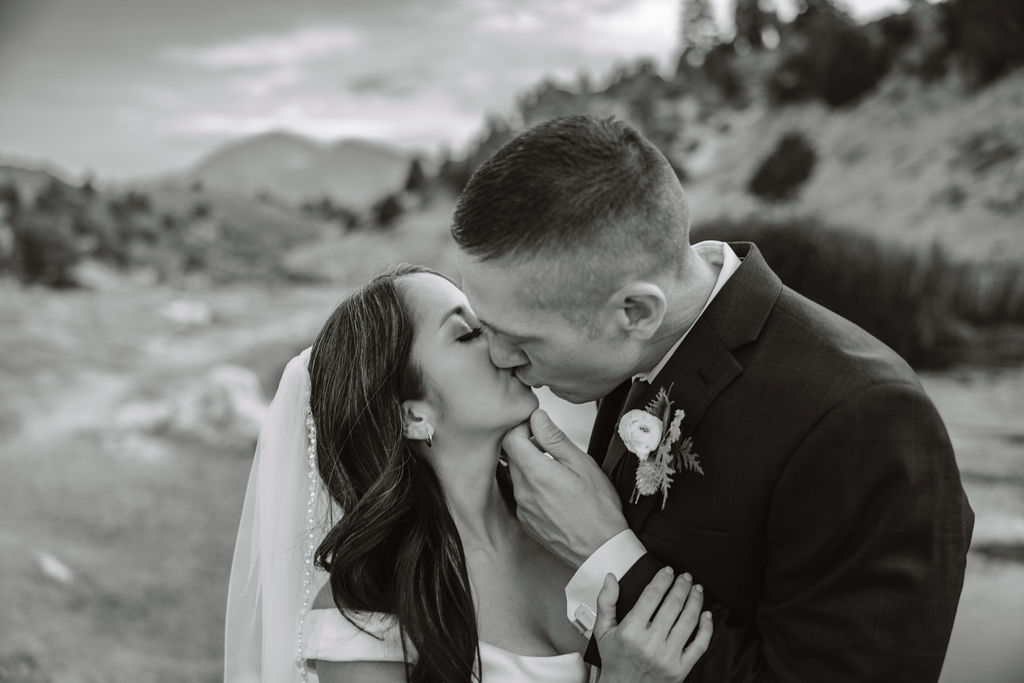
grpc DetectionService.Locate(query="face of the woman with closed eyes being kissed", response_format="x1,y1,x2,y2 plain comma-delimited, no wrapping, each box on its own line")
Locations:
398,273,538,436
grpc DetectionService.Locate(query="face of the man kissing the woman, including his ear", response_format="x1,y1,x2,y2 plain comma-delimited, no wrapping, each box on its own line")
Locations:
459,254,636,403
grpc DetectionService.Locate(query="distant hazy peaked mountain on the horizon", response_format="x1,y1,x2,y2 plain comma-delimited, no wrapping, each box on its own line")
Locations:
184,132,411,208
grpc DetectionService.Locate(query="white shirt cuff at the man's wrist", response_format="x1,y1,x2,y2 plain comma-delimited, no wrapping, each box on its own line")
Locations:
565,529,647,638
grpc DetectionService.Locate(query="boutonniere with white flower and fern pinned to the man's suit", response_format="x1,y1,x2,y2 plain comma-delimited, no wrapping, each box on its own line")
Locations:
618,385,703,510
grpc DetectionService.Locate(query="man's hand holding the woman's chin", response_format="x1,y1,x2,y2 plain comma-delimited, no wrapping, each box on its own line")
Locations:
502,410,628,569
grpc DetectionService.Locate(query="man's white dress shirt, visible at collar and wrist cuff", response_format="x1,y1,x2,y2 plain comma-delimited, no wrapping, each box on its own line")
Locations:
565,241,741,638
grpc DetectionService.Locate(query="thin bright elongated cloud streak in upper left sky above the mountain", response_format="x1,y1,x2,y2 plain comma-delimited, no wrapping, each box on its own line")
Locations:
162,26,361,70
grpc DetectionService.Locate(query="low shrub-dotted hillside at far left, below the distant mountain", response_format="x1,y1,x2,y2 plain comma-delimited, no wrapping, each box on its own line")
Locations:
0,166,327,289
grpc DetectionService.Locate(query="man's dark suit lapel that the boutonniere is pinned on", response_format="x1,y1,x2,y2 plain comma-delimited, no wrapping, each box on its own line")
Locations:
612,243,782,529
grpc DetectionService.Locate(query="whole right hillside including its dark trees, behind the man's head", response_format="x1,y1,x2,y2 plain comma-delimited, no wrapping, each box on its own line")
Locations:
442,0,1024,262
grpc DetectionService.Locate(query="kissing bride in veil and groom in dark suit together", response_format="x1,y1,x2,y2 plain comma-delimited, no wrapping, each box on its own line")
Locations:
225,116,974,683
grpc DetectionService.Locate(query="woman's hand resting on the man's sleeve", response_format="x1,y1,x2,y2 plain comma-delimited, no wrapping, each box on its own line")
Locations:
594,567,713,683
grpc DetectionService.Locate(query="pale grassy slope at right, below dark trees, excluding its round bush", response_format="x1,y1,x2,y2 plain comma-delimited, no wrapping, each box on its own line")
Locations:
682,71,1024,261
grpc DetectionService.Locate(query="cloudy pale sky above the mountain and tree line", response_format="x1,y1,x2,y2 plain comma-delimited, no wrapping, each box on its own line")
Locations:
0,0,907,180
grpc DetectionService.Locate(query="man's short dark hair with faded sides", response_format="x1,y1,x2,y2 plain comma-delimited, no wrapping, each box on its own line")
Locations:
452,116,689,278
